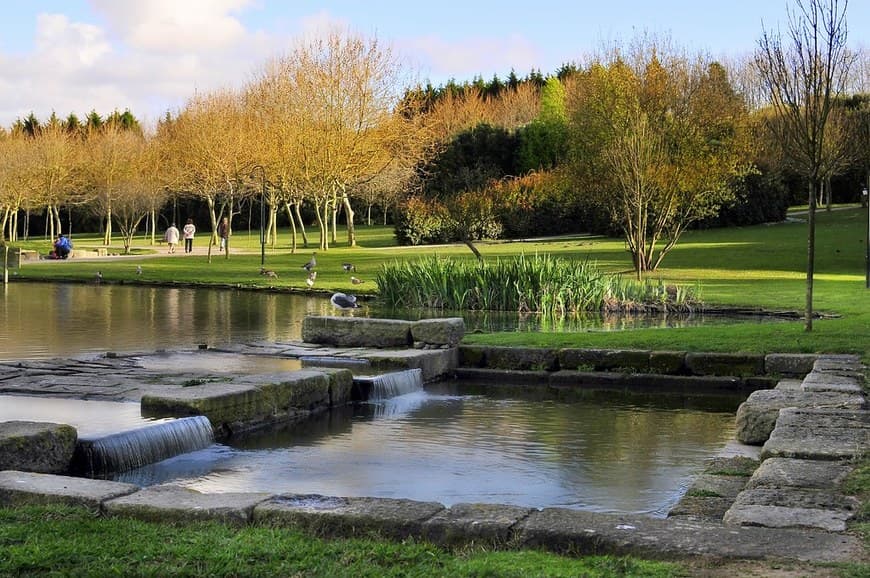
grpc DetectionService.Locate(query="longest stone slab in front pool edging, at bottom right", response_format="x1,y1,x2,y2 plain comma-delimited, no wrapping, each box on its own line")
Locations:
517,508,863,562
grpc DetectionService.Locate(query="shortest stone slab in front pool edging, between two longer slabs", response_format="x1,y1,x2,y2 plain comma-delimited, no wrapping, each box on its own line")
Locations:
423,504,532,546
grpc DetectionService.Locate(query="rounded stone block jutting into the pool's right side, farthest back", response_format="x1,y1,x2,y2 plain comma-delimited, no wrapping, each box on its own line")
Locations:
735,388,866,444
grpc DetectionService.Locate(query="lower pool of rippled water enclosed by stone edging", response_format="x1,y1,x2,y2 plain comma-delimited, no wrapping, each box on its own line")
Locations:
122,385,738,516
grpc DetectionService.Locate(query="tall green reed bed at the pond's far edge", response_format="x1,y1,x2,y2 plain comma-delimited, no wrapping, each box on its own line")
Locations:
376,254,701,317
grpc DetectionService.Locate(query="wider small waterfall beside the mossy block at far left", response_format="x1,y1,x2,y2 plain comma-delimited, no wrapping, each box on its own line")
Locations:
73,415,214,477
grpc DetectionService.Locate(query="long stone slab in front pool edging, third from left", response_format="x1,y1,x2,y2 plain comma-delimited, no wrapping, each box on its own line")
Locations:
254,494,444,540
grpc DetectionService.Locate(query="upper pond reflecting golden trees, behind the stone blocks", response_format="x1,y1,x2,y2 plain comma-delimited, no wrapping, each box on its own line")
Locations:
0,282,792,361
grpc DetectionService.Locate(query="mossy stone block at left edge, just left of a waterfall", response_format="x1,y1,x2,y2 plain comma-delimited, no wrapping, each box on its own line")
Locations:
0,421,78,474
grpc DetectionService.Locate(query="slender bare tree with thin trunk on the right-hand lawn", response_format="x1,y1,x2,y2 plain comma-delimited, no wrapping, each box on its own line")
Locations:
755,0,853,331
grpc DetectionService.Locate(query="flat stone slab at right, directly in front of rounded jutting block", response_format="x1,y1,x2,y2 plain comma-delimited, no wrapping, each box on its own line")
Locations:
761,408,870,461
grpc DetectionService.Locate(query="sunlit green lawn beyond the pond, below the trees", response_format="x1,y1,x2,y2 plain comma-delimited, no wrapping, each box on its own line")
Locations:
8,206,870,361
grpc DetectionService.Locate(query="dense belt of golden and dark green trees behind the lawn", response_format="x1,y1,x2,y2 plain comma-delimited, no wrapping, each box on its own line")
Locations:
0,6,870,272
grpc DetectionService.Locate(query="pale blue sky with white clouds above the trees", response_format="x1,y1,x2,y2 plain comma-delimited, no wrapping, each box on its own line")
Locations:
0,0,870,127
